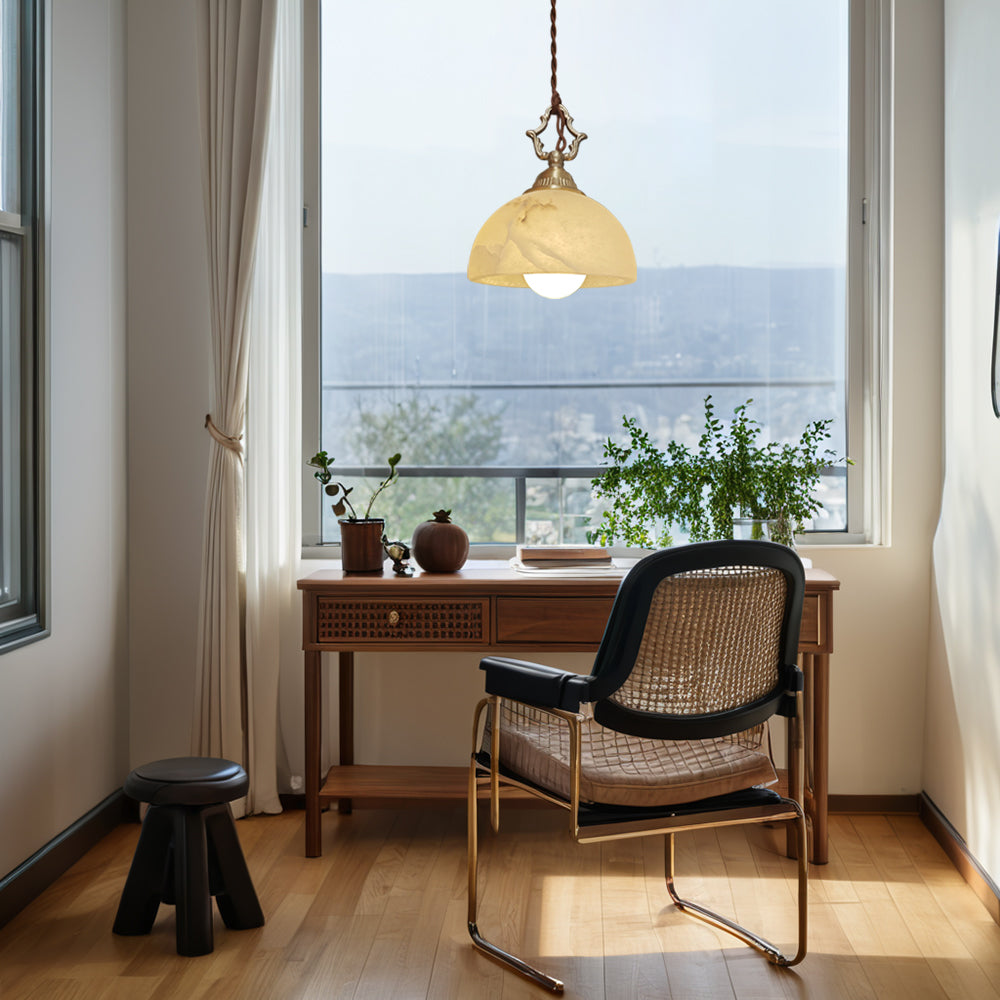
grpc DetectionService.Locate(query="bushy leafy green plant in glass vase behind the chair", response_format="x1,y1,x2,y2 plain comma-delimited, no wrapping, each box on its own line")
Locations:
588,396,850,548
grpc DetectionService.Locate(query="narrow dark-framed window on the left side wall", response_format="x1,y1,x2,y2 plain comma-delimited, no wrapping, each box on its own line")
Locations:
0,0,42,649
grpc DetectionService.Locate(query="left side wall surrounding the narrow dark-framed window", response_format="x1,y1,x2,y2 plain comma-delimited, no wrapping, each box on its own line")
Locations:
0,0,128,873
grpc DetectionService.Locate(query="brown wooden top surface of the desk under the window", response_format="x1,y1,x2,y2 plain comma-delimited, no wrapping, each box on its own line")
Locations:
298,559,840,598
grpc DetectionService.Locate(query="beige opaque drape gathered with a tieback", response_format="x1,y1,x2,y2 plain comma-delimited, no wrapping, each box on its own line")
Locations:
192,0,277,811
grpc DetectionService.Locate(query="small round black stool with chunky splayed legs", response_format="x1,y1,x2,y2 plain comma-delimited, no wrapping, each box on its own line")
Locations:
113,757,264,955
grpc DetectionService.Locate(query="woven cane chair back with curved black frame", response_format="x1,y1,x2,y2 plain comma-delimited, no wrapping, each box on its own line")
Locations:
589,541,805,739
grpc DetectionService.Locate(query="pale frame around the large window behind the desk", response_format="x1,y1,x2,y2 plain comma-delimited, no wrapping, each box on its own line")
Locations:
302,0,892,558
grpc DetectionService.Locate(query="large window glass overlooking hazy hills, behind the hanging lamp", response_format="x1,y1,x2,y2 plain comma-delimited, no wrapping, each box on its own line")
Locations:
306,0,865,543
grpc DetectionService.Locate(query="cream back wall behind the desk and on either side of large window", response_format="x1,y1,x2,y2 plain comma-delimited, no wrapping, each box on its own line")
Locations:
129,0,942,794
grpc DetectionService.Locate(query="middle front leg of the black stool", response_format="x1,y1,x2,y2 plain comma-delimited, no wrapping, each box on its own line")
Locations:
174,806,213,955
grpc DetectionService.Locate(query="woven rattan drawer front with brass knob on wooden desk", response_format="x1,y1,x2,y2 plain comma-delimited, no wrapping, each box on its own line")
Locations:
316,597,490,648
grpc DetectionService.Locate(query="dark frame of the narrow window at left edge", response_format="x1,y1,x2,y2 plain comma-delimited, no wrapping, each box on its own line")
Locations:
0,0,49,653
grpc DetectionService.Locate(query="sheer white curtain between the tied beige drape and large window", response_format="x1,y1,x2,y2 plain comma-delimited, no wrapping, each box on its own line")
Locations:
246,0,302,812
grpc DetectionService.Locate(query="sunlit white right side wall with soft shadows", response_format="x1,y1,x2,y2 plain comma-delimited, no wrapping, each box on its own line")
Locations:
924,0,1000,882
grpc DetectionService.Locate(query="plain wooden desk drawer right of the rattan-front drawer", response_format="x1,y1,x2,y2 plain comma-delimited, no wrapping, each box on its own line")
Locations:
497,597,614,648
